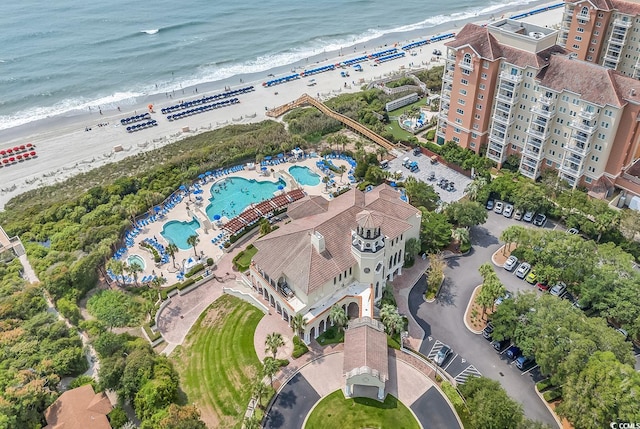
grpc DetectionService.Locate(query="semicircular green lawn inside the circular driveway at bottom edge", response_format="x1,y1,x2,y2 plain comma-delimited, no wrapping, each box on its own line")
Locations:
305,390,420,429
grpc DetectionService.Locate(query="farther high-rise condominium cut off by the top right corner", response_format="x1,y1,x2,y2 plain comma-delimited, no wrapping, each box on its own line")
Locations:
558,0,640,79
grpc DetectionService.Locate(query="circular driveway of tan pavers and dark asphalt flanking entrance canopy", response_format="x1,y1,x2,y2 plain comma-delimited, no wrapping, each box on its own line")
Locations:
264,352,461,429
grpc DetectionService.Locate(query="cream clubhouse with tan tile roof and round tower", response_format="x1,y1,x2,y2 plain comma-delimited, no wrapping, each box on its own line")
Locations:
250,185,421,343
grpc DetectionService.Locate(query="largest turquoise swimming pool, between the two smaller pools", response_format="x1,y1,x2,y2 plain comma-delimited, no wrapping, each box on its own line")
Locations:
206,177,285,220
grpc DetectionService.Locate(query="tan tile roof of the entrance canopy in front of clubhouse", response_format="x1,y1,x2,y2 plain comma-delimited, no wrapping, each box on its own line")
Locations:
342,317,389,381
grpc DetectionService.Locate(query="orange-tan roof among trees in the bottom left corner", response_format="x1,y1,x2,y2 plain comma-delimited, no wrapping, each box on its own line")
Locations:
44,384,112,429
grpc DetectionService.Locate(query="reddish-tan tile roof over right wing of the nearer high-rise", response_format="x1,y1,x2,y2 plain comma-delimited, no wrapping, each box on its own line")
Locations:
537,55,640,107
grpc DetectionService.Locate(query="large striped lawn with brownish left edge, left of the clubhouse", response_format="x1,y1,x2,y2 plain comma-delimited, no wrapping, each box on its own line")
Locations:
171,295,263,428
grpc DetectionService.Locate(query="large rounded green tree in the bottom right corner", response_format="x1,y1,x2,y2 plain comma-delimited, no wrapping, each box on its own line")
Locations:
558,352,640,429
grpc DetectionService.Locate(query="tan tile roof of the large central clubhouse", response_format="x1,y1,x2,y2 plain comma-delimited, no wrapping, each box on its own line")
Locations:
253,188,418,294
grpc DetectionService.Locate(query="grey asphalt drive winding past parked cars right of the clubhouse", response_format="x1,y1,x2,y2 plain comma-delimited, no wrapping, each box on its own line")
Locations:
409,212,557,427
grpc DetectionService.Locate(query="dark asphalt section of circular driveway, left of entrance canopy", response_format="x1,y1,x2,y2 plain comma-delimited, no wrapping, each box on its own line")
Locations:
264,373,320,429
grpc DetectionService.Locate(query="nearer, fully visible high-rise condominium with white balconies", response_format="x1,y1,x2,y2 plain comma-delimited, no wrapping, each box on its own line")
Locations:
436,19,640,189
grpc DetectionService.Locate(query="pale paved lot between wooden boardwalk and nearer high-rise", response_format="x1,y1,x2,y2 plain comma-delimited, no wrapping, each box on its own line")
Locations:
389,151,471,203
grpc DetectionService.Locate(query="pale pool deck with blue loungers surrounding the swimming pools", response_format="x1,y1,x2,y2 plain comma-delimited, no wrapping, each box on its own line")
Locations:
121,157,350,287
